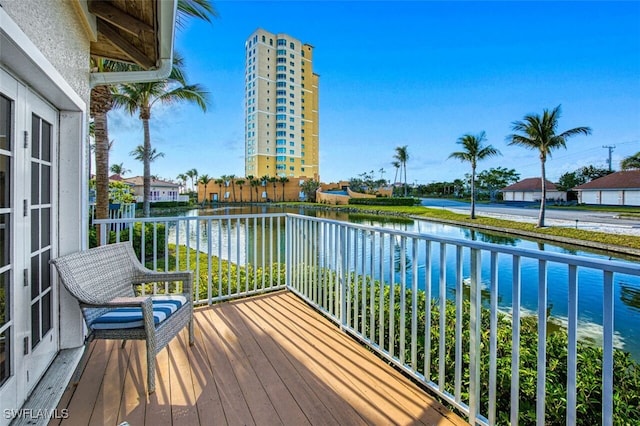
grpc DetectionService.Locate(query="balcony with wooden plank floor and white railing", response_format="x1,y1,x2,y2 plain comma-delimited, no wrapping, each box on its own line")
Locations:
43,213,640,425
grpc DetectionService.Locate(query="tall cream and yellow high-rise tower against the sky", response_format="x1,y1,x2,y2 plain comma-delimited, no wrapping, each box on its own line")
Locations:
245,29,320,179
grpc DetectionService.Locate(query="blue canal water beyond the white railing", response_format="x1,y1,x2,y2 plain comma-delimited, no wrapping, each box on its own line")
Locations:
166,206,640,361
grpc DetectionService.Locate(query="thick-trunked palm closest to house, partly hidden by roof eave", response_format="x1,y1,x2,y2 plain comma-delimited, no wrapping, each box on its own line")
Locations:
89,0,218,225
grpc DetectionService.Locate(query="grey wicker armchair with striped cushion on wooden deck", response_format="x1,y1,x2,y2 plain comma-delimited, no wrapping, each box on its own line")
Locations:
51,242,194,393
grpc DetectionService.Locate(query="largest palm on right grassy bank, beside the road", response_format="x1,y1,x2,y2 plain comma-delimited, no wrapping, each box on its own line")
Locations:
507,105,591,227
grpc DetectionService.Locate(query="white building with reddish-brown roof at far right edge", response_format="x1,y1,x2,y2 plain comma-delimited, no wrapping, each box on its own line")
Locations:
573,170,640,206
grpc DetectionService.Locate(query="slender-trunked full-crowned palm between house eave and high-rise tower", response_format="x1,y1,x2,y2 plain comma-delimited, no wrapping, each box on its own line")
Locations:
113,54,207,217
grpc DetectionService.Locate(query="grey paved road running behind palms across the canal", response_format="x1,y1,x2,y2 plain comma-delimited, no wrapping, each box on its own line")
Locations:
422,198,640,228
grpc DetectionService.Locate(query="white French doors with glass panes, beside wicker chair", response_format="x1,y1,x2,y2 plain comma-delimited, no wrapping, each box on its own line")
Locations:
0,69,58,423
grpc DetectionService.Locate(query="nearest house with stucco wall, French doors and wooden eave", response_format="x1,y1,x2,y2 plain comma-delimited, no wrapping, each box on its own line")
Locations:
0,0,176,425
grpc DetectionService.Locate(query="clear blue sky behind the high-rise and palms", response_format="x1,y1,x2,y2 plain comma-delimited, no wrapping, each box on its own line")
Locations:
109,1,640,183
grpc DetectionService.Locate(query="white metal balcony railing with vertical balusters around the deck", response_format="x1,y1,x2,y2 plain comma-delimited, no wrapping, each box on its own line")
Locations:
96,214,640,425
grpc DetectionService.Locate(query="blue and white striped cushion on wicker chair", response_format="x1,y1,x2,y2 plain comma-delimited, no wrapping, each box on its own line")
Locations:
91,295,187,330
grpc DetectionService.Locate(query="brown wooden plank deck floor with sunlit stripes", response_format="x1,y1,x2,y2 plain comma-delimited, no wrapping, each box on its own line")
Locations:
51,292,465,426
